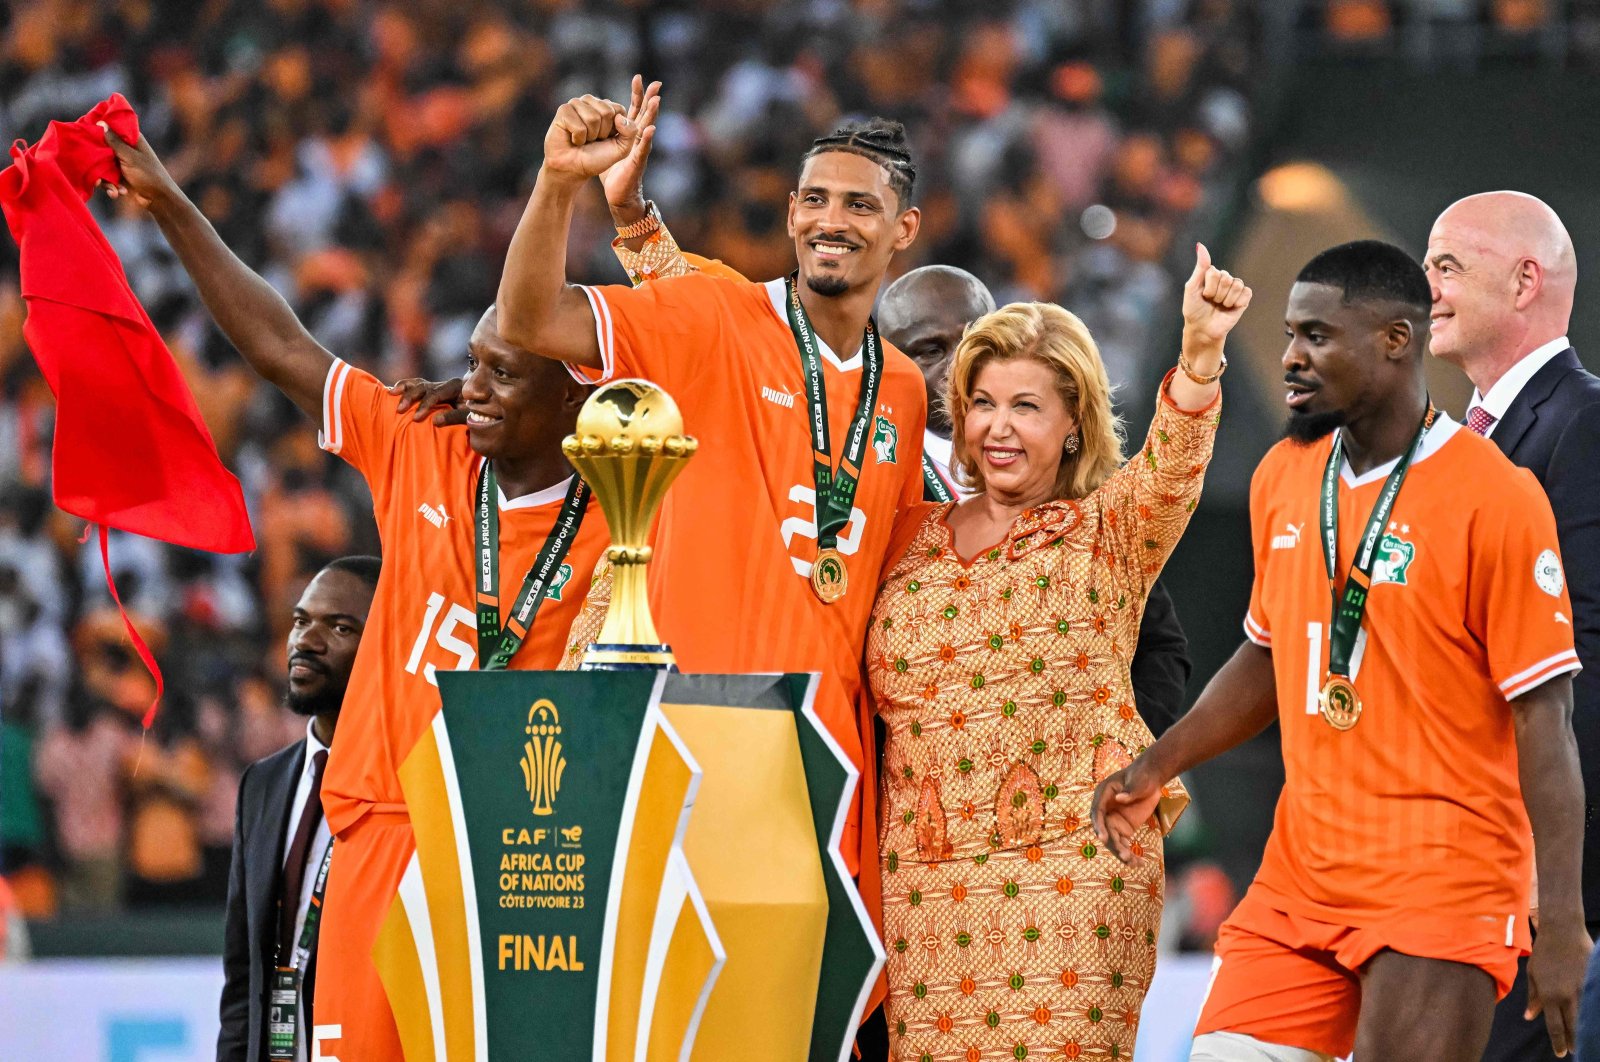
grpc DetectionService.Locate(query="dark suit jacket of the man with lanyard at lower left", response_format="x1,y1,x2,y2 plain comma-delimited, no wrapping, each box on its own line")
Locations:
216,739,317,1062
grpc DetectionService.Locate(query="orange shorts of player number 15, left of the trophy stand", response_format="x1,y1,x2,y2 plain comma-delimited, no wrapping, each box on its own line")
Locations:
312,814,416,1062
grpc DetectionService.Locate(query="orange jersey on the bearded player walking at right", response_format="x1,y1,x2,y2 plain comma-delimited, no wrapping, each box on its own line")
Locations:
1245,416,1578,948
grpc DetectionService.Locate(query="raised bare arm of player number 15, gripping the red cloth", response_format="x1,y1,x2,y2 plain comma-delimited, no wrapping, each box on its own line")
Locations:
106,130,333,419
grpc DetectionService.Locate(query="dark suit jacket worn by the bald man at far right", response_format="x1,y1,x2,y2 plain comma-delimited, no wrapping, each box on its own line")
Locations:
1491,349,1600,921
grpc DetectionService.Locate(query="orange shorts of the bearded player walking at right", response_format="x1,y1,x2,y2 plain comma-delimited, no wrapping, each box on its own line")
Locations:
1195,891,1522,1057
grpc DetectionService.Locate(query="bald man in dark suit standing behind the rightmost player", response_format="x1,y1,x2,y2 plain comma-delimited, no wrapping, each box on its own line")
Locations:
1424,192,1600,1062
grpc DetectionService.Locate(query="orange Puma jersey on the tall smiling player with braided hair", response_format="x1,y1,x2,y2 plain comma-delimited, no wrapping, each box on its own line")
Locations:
573,273,928,860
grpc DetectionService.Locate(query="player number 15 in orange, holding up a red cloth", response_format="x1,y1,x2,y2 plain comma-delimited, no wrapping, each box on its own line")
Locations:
107,133,611,1062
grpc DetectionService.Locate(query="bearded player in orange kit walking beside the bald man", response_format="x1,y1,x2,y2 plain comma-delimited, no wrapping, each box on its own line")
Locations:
1093,240,1590,1062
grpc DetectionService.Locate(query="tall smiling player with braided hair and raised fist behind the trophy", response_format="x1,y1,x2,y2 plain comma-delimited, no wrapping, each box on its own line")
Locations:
499,89,926,902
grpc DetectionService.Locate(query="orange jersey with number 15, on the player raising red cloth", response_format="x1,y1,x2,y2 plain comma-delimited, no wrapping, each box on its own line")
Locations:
320,361,611,833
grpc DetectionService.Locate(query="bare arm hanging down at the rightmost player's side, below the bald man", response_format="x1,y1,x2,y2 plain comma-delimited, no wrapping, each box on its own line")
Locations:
1510,677,1594,1056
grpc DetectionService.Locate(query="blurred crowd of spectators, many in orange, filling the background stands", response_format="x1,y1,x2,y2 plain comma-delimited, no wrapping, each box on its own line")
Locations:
0,0,1261,927
